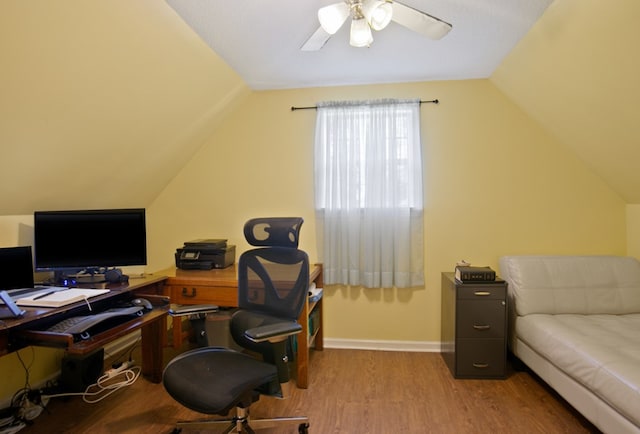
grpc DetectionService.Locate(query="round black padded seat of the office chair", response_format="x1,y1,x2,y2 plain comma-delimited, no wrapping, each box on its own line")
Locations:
162,347,278,415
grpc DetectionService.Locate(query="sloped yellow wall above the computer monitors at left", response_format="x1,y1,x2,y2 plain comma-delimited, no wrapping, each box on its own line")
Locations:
0,0,249,215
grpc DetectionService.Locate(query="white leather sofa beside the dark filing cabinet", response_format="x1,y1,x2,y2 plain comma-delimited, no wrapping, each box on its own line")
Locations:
500,256,640,434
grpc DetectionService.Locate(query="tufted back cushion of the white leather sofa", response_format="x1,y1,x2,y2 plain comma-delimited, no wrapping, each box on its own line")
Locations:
500,256,640,315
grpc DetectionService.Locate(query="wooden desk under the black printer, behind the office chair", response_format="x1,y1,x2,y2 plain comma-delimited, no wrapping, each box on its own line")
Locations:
159,264,323,389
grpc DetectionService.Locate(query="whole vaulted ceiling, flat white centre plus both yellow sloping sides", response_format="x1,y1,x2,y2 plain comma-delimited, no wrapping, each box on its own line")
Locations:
0,0,640,215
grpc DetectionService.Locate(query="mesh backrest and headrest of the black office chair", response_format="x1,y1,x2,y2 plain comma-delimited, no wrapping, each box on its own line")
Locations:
238,217,309,320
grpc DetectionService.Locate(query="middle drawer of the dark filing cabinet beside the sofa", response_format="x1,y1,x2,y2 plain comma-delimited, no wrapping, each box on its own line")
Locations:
456,299,506,338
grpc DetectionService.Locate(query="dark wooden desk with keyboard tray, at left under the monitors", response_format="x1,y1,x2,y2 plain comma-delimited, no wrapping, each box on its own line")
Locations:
0,275,169,383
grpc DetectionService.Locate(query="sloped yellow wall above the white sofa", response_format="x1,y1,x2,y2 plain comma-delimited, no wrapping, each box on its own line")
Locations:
491,0,640,204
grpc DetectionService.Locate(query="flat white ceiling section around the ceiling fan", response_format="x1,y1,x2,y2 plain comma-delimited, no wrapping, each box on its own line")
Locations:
167,0,552,90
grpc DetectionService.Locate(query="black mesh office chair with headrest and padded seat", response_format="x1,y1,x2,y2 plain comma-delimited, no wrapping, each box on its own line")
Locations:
163,217,309,433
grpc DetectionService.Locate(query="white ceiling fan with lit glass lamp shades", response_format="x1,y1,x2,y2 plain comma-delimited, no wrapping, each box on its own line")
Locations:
300,0,453,51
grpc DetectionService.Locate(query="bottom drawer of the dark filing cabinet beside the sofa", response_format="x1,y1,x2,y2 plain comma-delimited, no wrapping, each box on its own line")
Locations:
456,339,506,378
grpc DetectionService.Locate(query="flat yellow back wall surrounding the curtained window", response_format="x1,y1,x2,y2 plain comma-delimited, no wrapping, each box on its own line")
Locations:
149,80,626,342
